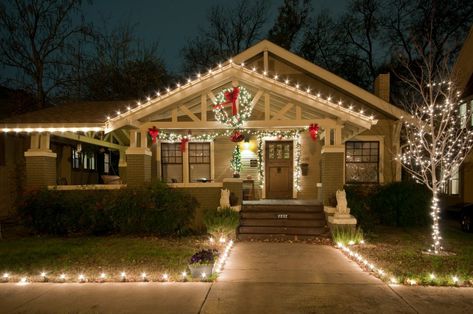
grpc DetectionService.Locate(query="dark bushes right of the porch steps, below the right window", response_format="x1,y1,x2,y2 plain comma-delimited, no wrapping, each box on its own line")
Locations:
345,180,432,232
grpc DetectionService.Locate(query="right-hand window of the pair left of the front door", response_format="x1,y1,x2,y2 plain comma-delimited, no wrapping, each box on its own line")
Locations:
189,143,210,182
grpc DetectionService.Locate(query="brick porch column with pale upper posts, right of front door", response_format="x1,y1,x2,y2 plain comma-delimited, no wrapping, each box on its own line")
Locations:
321,127,345,205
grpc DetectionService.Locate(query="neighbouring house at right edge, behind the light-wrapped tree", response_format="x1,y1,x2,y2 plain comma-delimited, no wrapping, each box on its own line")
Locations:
445,27,473,205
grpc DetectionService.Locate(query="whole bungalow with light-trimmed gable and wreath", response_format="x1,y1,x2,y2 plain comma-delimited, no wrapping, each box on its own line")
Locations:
0,40,405,216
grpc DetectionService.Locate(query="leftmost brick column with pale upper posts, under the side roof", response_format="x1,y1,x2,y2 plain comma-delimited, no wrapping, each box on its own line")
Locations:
25,133,57,190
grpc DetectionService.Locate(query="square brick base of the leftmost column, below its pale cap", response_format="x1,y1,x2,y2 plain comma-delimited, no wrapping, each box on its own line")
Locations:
25,156,56,189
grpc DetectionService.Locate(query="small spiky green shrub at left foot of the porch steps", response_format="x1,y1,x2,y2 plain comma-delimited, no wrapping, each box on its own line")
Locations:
204,208,240,239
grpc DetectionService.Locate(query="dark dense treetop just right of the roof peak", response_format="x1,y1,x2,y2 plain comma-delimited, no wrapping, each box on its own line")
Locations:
268,0,311,50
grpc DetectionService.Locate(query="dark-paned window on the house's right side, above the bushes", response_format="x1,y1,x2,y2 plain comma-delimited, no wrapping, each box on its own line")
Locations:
345,141,379,183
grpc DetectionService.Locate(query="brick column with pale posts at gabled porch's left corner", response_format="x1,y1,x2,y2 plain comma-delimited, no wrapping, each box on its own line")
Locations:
126,130,151,187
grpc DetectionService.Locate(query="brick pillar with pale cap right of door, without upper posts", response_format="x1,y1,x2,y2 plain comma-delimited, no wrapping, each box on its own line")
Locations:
322,145,345,205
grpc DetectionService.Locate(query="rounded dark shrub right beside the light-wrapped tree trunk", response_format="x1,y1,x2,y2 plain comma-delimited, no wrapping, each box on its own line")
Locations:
371,181,432,227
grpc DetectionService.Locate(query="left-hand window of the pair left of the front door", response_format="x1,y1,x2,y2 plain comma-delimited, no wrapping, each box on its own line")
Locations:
161,143,182,183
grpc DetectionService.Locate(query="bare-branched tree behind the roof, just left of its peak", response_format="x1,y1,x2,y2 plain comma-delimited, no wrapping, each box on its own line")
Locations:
182,0,267,74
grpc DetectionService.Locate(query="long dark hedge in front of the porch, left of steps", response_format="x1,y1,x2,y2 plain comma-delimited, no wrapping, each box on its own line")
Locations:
19,182,198,235
